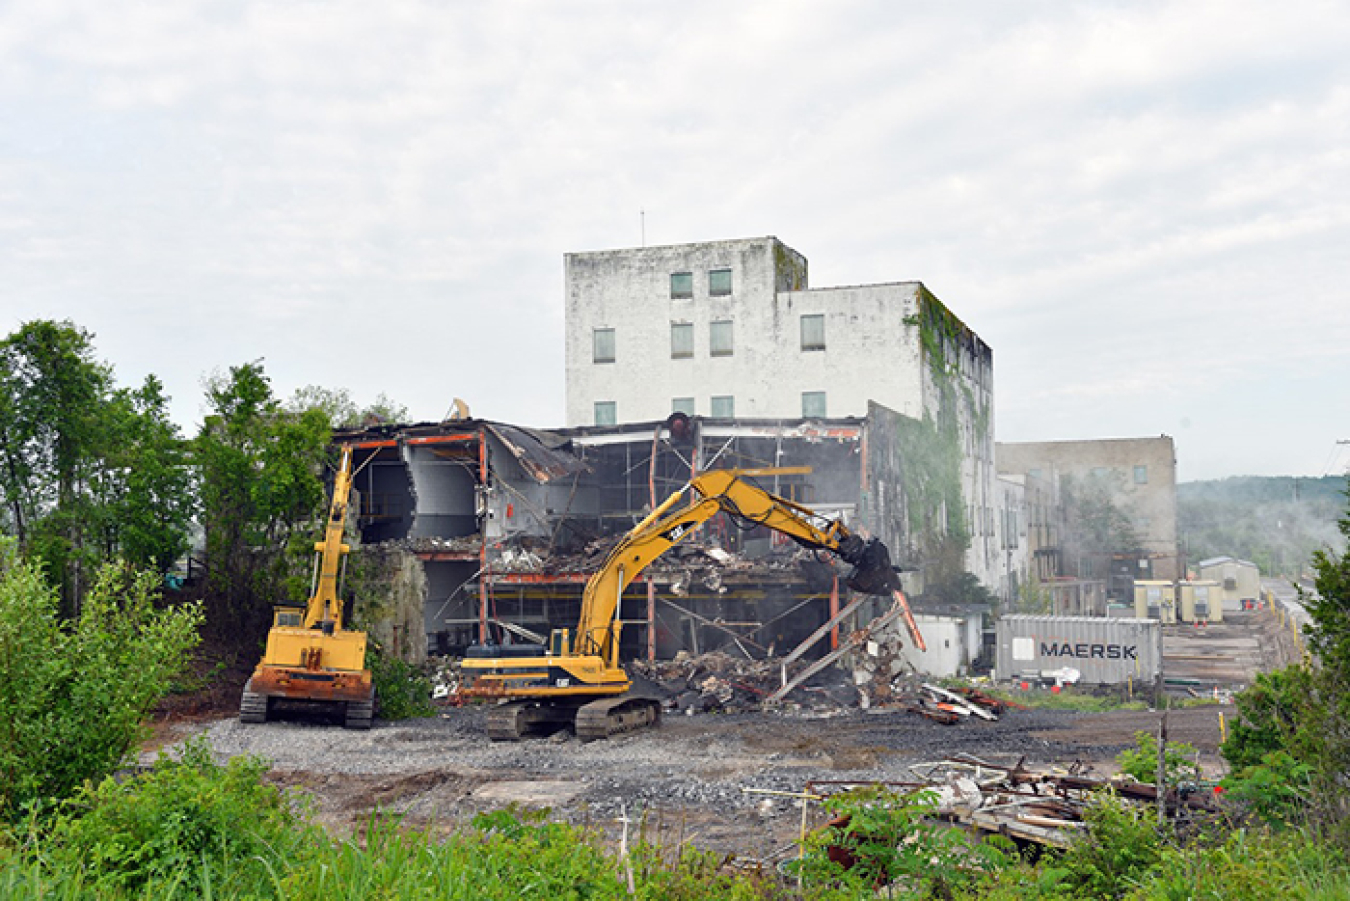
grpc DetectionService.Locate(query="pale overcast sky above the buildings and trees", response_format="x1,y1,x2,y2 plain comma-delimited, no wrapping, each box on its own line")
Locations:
0,0,1350,481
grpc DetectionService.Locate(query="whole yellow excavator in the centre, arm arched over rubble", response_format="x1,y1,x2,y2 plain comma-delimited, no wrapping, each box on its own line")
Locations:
459,469,903,742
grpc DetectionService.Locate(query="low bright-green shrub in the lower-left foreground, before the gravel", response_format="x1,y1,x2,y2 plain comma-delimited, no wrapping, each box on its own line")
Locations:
43,740,314,897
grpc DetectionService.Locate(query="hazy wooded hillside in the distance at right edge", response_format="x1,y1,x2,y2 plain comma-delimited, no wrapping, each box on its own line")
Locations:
1177,475,1346,575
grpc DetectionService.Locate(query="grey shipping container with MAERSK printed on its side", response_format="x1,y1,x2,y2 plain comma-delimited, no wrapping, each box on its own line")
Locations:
995,616,1162,685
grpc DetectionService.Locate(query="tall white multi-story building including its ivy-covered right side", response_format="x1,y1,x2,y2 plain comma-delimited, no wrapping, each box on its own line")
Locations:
566,238,1007,586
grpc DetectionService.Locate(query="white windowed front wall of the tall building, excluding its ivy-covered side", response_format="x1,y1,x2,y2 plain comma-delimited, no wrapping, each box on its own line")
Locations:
566,238,990,426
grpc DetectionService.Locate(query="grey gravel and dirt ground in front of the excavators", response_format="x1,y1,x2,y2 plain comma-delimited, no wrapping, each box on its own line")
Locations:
147,708,1236,858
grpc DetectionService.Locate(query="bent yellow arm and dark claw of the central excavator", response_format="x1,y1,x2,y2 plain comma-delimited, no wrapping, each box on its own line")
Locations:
571,469,900,666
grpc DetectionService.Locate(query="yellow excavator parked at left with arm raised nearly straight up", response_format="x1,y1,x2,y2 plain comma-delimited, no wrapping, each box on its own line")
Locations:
239,447,375,729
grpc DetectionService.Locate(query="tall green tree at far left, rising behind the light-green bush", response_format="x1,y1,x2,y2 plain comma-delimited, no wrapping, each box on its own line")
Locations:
0,320,193,615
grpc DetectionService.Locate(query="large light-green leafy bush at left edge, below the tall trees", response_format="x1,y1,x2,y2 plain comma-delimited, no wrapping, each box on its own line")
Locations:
0,543,201,821
